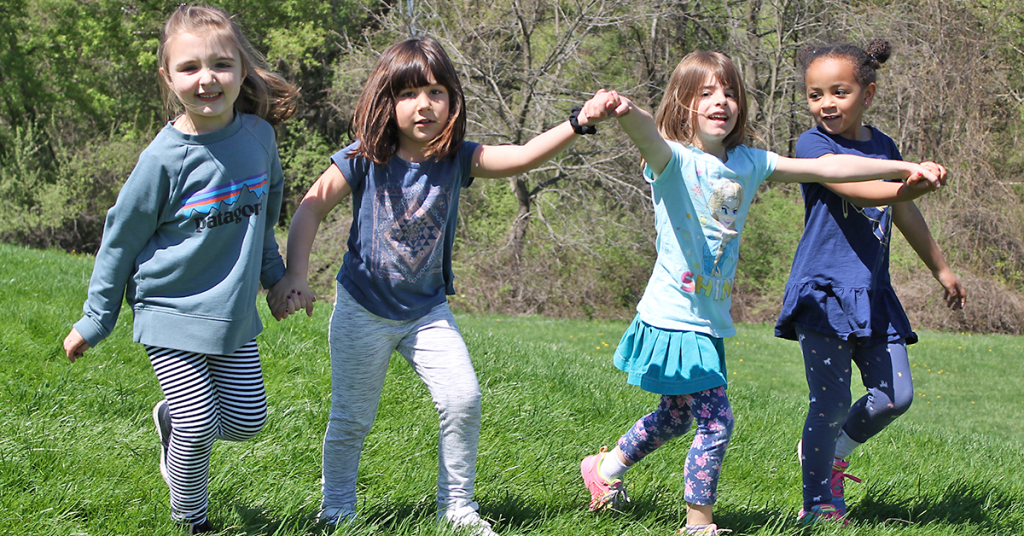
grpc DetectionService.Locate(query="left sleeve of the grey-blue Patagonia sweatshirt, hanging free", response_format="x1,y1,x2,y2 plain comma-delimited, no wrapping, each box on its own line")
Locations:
75,151,171,347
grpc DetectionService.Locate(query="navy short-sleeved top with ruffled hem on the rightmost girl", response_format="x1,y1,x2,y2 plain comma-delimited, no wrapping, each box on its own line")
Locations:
775,127,918,344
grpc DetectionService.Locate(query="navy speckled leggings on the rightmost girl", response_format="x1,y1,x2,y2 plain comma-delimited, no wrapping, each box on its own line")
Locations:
797,327,913,508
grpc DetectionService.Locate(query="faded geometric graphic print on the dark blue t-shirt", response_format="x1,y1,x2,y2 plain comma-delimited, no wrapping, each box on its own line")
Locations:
368,184,447,282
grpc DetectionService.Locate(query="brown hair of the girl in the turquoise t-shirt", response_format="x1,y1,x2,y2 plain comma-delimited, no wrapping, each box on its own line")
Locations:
654,51,748,150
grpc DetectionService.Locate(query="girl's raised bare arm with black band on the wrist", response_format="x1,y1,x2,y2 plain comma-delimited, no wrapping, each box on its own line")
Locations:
472,91,609,178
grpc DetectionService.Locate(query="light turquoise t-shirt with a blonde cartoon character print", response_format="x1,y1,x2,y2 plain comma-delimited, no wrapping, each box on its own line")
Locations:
637,141,778,338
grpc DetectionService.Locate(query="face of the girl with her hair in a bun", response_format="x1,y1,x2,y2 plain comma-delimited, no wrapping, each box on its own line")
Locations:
804,56,876,141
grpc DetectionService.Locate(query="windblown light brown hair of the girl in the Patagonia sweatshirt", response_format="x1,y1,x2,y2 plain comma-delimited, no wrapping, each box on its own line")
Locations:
157,4,299,125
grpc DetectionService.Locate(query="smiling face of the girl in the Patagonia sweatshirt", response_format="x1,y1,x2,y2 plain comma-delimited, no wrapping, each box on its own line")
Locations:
160,33,245,134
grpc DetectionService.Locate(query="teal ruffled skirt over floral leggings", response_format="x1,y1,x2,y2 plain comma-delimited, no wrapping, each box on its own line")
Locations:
614,315,728,395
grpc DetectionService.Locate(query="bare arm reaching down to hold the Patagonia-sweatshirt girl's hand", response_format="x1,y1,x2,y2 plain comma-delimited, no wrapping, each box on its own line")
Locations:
266,163,352,320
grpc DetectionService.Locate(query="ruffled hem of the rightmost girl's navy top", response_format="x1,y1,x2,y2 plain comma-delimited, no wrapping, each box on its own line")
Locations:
775,281,918,344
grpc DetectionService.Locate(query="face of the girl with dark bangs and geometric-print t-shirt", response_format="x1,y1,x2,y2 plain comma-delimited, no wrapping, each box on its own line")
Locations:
394,76,449,161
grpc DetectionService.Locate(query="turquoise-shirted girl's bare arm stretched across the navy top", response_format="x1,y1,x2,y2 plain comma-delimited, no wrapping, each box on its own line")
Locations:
768,155,939,185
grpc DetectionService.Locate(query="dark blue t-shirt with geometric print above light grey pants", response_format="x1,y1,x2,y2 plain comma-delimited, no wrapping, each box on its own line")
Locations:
331,141,479,320
